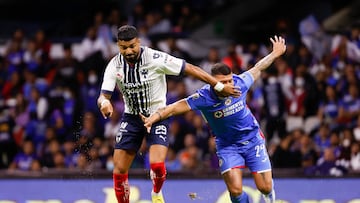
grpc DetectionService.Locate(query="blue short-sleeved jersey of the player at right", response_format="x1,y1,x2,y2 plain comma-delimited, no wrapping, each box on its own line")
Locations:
186,72,260,142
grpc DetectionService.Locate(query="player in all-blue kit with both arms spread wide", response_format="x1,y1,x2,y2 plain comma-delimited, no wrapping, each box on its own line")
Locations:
141,36,286,203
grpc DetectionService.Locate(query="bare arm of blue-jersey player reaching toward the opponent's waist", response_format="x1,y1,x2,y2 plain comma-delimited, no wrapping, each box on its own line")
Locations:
140,99,191,132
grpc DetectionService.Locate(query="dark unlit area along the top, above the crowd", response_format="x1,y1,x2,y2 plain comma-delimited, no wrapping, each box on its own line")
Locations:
0,0,353,41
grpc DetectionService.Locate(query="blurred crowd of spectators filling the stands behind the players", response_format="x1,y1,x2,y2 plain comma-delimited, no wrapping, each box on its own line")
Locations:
0,0,360,176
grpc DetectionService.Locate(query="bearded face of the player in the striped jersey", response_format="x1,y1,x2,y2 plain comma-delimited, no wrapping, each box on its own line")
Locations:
117,38,140,64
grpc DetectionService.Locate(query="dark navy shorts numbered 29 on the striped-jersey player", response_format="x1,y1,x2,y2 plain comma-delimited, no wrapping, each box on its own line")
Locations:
115,113,169,151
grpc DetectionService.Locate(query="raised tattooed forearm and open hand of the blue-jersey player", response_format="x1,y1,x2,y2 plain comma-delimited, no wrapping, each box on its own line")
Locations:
249,36,286,80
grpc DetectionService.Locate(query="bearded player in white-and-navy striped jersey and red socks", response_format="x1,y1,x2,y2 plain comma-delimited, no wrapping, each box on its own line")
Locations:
97,25,240,203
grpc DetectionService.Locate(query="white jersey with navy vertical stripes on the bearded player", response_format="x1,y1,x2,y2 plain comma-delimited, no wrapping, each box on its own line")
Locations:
101,47,185,115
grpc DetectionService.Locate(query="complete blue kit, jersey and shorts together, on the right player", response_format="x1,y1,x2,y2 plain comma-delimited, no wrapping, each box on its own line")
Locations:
186,72,271,174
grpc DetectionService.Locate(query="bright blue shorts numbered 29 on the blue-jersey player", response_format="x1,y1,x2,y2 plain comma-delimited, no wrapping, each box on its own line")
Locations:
216,132,271,174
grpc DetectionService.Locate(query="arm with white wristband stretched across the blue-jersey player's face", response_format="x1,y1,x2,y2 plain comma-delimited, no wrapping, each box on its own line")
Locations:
185,63,240,97
